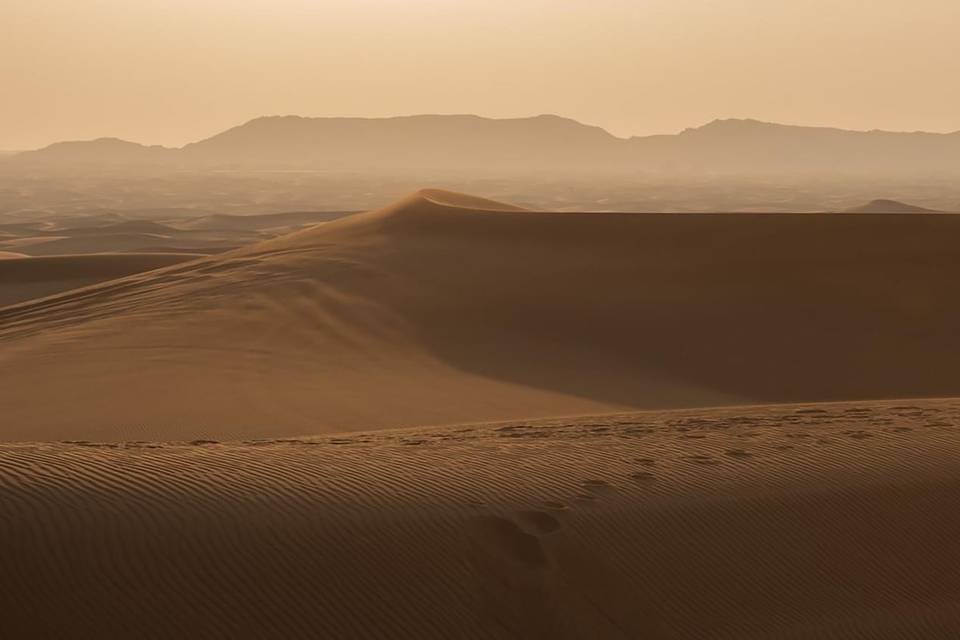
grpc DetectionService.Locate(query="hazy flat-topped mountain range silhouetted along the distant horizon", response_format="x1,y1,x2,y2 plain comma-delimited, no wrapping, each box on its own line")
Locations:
6,115,960,175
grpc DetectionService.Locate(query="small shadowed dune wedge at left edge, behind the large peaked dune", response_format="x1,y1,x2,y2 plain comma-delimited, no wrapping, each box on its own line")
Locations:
0,253,197,308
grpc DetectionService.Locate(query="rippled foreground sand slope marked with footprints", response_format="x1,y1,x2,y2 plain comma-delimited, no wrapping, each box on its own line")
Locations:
0,400,960,640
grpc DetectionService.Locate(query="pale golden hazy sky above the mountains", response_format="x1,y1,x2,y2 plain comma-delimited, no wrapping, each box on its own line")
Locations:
0,0,960,149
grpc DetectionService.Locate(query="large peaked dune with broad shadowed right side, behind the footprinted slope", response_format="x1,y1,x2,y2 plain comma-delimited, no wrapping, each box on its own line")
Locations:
0,191,960,440
